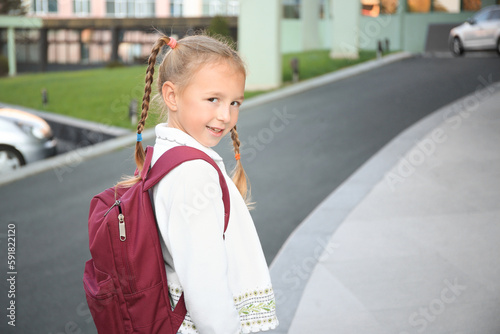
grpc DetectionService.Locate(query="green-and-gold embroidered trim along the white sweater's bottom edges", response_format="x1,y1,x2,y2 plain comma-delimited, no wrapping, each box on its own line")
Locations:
169,285,278,334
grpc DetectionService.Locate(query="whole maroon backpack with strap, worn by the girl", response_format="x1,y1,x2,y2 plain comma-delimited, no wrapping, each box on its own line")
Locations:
83,146,229,334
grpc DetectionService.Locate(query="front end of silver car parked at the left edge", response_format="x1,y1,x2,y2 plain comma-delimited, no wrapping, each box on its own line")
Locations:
0,108,56,174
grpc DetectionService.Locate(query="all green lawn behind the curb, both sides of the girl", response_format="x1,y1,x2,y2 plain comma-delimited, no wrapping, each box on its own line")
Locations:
0,50,376,129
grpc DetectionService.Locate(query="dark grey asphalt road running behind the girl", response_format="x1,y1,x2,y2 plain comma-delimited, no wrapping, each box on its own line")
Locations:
0,56,500,334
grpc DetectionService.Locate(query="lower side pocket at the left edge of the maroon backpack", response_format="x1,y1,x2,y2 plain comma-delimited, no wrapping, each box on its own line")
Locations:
83,259,125,334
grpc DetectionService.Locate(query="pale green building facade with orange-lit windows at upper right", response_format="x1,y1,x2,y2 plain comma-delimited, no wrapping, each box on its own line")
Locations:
281,0,500,53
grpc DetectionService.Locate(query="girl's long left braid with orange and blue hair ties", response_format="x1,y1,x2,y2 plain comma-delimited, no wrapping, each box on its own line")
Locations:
135,36,170,171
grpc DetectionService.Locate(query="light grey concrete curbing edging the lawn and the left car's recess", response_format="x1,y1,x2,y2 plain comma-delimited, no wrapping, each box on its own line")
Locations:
0,52,414,186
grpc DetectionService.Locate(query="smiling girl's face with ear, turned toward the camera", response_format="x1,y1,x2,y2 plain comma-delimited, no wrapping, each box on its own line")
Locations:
162,62,245,147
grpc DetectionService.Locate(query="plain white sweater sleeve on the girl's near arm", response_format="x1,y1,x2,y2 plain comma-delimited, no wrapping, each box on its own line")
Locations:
155,160,240,334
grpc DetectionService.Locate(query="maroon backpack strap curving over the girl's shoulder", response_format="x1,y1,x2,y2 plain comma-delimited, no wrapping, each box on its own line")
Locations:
141,146,230,319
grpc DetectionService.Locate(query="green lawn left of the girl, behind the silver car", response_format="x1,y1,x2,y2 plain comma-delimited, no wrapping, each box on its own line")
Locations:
0,66,145,128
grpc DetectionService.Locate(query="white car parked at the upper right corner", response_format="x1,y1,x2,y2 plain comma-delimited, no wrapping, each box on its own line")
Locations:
449,5,500,56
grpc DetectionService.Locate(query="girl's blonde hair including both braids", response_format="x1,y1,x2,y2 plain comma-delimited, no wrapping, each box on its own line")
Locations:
117,35,250,201
